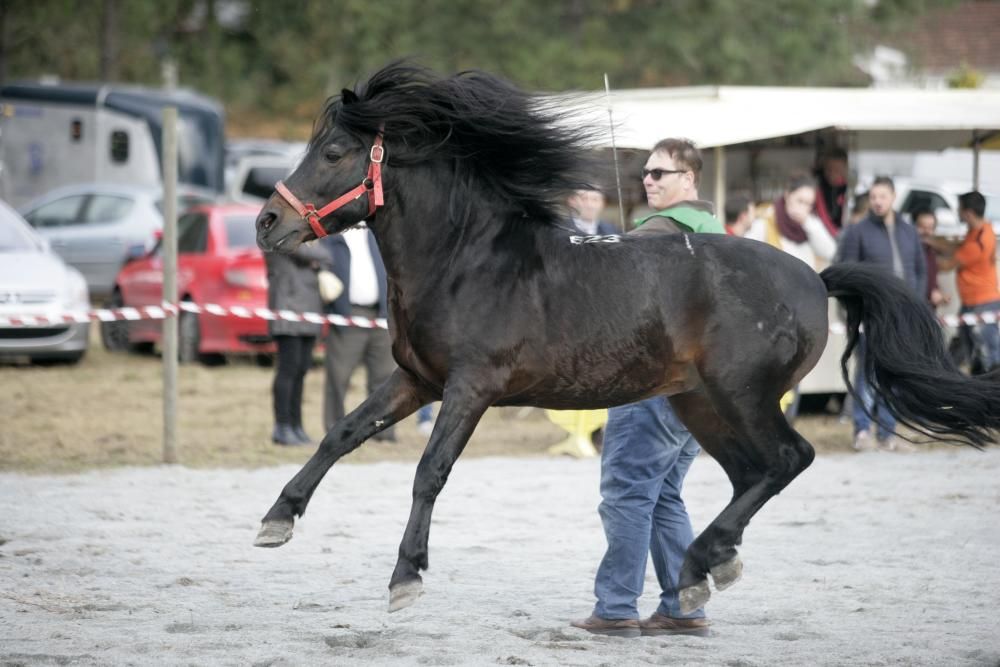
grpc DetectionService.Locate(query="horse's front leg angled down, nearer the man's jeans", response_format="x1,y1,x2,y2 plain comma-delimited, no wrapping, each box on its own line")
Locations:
389,388,493,612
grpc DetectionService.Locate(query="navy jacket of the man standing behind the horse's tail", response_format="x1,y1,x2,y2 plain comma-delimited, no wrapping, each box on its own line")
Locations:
834,213,927,298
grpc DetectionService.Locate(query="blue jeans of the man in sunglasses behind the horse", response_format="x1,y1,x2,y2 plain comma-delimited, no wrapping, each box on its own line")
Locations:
594,396,705,619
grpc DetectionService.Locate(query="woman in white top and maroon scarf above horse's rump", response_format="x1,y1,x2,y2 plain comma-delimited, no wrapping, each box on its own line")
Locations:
747,174,837,269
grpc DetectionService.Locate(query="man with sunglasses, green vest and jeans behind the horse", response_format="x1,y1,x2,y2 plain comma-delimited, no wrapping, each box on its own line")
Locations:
572,139,725,637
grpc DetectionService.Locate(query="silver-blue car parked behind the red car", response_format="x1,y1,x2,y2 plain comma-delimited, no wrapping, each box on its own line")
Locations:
21,183,212,298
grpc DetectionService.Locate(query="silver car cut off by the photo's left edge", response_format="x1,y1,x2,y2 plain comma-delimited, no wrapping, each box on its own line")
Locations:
0,202,90,363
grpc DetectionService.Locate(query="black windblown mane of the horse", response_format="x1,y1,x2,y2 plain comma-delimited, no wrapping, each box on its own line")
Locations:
310,62,595,223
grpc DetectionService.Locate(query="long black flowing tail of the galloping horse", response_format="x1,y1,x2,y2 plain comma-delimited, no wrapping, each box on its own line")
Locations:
820,264,1000,447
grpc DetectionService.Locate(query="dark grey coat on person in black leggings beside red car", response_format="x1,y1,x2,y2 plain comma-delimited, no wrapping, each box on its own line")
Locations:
264,244,333,336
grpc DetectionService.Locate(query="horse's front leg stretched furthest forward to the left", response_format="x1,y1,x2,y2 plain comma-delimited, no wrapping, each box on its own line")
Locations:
254,368,434,547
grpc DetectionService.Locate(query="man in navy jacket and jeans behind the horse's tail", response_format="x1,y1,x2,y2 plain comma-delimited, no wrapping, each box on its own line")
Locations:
836,176,927,451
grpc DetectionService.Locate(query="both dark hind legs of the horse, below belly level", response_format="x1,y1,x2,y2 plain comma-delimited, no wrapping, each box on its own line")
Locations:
671,395,815,613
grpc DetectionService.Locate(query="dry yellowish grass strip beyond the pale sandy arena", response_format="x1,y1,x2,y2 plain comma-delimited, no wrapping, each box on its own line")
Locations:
0,325,851,473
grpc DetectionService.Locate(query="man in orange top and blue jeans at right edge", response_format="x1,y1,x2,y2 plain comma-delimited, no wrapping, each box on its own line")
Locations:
941,190,1000,373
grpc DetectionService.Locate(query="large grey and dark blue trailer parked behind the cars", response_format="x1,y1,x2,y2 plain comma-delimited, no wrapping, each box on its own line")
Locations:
0,83,225,207
